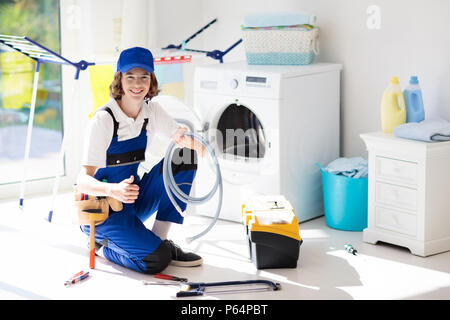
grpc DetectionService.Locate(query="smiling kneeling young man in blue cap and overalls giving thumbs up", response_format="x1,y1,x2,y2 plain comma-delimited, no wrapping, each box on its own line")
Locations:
77,47,204,273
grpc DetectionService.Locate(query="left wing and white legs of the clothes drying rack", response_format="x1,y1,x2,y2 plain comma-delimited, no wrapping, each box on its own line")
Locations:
0,35,95,222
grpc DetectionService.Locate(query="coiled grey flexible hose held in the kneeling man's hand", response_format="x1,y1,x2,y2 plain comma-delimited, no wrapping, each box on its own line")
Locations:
163,132,223,243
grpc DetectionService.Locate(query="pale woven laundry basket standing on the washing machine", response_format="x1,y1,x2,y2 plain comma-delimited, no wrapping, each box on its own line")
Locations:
242,25,319,65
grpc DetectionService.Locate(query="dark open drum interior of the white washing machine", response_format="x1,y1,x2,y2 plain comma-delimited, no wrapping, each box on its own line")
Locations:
216,103,266,158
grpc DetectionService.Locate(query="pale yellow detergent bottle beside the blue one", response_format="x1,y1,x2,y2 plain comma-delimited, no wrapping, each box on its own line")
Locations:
381,77,406,133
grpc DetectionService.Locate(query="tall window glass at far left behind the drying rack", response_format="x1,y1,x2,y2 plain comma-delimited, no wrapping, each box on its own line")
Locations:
0,0,63,185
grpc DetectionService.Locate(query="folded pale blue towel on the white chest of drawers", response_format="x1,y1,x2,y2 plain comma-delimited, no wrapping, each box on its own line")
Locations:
394,119,450,142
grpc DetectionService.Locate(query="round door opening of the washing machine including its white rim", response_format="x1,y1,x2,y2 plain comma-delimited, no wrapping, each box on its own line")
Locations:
208,101,268,184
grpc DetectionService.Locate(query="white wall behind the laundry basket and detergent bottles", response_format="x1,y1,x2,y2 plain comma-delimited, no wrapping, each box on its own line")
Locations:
188,0,450,156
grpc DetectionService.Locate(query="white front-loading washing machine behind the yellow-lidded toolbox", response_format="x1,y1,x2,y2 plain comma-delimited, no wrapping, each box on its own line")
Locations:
193,61,342,222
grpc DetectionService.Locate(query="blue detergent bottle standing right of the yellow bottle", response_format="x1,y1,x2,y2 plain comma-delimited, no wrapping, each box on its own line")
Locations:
403,76,425,122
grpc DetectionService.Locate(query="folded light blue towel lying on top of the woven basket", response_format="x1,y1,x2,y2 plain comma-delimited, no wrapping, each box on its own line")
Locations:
242,12,317,28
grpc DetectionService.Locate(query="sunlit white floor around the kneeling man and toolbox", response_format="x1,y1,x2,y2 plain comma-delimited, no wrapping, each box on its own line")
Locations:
0,194,450,300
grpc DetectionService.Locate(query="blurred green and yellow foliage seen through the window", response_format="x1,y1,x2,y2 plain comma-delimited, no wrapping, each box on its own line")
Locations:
0,0,62,131
